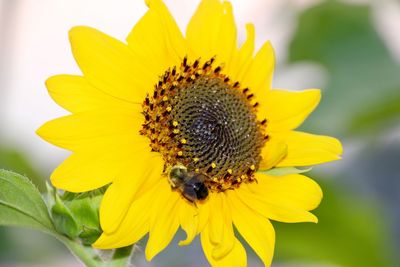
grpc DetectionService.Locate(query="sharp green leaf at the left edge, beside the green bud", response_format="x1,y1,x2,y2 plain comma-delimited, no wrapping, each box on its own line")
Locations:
0,170,54,233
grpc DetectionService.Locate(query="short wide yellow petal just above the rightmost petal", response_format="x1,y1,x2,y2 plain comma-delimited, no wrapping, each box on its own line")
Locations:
259,89,321,131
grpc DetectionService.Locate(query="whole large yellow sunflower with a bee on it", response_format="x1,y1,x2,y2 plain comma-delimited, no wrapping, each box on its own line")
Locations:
38,0,342,266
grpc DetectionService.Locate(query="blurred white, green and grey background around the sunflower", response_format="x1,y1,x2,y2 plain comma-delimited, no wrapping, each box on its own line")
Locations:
0,0,400,267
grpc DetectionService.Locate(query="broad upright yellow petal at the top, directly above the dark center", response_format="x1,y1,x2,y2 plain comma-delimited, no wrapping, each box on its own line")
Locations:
186,0,236,68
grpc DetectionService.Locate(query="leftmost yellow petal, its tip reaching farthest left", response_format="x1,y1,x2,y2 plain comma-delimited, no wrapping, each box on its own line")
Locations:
37,106,143,151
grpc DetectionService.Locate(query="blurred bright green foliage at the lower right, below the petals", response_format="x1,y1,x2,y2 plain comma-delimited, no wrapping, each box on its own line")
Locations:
274,179,395,267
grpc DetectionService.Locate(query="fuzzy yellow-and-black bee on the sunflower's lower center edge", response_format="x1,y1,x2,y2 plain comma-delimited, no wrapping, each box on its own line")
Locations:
169,165,209,205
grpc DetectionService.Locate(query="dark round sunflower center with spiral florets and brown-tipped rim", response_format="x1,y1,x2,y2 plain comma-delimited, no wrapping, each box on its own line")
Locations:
141,59,266,191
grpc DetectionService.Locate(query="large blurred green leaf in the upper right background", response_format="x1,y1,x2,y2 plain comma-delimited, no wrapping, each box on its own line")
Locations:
289,1,400,137
